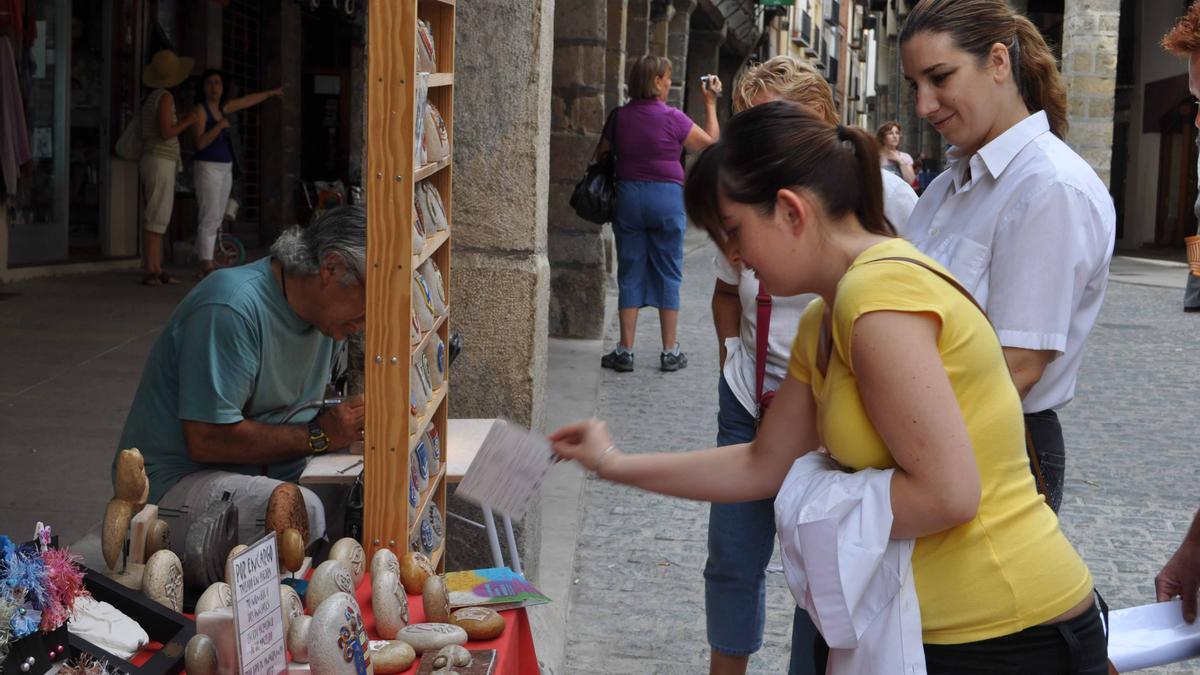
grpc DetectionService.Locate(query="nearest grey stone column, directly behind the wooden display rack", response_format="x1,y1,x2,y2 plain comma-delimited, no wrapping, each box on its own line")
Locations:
446,0,552,571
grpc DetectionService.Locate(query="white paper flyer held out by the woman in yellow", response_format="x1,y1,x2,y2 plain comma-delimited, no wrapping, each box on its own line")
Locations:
455,419,554,520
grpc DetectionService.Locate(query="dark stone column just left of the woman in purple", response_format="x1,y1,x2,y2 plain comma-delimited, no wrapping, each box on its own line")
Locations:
548,0,610,338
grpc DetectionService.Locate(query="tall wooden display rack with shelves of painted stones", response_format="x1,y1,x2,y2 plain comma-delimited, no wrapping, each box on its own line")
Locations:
362,0,455,569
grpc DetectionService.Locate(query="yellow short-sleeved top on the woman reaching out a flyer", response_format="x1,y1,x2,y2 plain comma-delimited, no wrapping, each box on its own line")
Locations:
788,239,1092,644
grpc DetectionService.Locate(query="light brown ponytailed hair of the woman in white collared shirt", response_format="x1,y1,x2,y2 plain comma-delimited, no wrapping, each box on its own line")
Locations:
900,0,1069,139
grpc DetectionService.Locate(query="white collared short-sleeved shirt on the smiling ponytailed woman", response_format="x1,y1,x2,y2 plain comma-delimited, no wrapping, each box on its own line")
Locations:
901,112,1116,412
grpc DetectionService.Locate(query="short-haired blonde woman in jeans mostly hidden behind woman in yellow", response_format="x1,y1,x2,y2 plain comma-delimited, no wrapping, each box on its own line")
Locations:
704,56,917,675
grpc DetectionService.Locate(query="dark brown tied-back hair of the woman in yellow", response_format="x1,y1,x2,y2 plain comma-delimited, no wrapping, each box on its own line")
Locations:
684,101,895,245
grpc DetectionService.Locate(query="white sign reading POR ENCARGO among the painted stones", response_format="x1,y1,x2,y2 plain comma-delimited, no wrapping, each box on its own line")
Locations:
230,532,288,675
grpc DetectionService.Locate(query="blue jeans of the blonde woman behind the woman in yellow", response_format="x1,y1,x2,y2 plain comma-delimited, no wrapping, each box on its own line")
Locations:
704,376,817,675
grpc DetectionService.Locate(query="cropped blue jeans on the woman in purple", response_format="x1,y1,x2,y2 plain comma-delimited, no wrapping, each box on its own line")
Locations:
612,180,688,310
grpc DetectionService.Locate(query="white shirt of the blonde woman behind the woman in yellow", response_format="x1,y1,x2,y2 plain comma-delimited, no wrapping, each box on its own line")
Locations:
713,171,917,414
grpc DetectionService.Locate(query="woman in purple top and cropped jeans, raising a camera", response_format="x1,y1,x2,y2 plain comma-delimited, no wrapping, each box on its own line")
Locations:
596,55,721,372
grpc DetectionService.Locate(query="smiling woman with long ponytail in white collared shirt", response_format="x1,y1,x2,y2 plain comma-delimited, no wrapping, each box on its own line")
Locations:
900,0,1116,510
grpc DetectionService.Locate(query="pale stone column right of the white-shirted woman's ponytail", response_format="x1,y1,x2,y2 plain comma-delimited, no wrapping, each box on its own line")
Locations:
1062,0,1121,185
